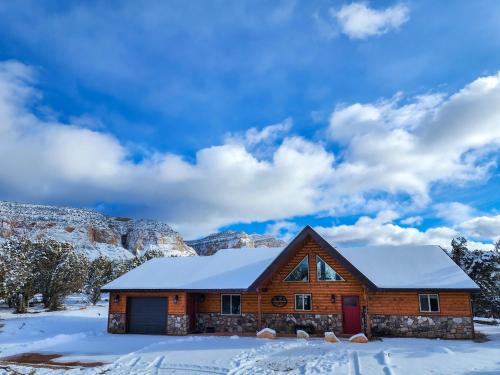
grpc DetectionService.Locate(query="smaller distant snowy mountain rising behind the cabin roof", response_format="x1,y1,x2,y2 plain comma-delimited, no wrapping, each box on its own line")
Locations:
186,230,286,255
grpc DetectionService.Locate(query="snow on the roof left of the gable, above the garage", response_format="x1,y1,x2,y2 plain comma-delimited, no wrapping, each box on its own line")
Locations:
103,248,282,290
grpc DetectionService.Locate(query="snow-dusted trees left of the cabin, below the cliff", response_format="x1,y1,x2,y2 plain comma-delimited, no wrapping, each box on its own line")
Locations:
0,238,168,313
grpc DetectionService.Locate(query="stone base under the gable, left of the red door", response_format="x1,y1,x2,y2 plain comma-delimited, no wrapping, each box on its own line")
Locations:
262,314,342,334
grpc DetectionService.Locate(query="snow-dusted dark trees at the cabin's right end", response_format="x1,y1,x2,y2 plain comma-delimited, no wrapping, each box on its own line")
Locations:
450,237,500,318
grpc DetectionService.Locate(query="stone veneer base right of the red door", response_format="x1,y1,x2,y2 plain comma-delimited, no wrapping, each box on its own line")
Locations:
371,315,474,339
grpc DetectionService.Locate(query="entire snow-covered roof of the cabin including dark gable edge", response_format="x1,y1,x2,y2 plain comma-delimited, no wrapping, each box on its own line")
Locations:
103,227,478,290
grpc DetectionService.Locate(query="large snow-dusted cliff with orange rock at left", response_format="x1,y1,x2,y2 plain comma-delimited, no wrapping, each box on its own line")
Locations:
0,201,196,258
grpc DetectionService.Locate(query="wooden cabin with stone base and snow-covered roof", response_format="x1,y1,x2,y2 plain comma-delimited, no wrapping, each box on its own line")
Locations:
103,226,479,339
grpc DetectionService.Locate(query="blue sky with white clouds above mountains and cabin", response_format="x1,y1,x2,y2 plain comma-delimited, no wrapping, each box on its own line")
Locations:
0,1,500,246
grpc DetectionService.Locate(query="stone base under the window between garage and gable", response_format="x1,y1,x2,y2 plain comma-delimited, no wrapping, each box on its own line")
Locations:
196,313,257,333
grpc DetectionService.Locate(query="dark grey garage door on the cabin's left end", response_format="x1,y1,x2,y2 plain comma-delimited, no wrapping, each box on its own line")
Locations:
127,297,167,335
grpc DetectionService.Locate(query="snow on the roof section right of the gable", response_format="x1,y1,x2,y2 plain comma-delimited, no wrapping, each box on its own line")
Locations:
337,245,479,289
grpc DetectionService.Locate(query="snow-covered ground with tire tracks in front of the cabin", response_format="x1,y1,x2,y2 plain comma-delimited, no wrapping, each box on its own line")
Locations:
0,304,500,375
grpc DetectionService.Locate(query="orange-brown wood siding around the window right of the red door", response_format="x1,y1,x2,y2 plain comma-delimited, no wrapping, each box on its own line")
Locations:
368,291,472,316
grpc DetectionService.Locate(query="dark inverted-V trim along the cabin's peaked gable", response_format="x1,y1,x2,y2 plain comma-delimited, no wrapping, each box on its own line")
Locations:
248,225,378,291
